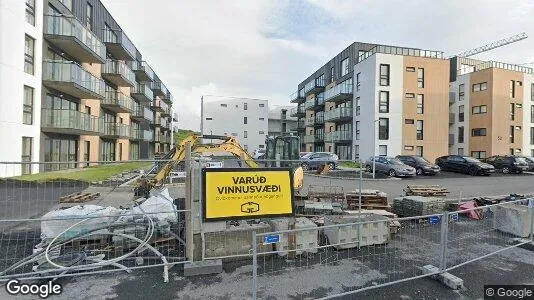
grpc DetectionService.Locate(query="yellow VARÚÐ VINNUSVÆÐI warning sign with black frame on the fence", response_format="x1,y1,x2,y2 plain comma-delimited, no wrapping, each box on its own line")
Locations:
203,168,293,221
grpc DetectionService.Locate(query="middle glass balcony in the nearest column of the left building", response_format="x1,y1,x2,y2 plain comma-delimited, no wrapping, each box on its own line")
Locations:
43,61,106,99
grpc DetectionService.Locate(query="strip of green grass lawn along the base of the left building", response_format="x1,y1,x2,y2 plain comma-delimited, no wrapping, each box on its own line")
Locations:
11,162,152,182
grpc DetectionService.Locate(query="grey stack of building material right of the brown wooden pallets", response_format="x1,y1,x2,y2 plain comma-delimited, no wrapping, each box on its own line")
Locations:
393,196,445,217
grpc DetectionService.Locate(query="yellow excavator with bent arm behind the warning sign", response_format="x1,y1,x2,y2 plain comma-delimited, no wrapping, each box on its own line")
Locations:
134,134,304,198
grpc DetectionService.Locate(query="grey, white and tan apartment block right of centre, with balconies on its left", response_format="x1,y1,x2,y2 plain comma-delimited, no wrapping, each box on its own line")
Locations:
291,42,449,159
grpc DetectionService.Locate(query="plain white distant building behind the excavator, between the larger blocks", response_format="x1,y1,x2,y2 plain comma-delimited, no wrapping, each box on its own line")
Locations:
200,96,269,152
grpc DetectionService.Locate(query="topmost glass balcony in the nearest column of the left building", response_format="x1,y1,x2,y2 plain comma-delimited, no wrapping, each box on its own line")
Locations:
43,15,106,63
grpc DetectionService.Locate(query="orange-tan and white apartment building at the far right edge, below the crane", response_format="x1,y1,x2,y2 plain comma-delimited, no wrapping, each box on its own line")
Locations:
449,57,534,158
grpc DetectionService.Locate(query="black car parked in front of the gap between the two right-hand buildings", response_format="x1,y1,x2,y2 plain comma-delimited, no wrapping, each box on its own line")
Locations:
436,155,495,176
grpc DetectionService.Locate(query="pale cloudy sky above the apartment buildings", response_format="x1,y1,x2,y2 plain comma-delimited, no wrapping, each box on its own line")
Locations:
101,0,534,130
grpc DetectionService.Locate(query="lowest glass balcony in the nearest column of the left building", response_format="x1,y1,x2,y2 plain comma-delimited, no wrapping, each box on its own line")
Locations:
41,109,102,135
